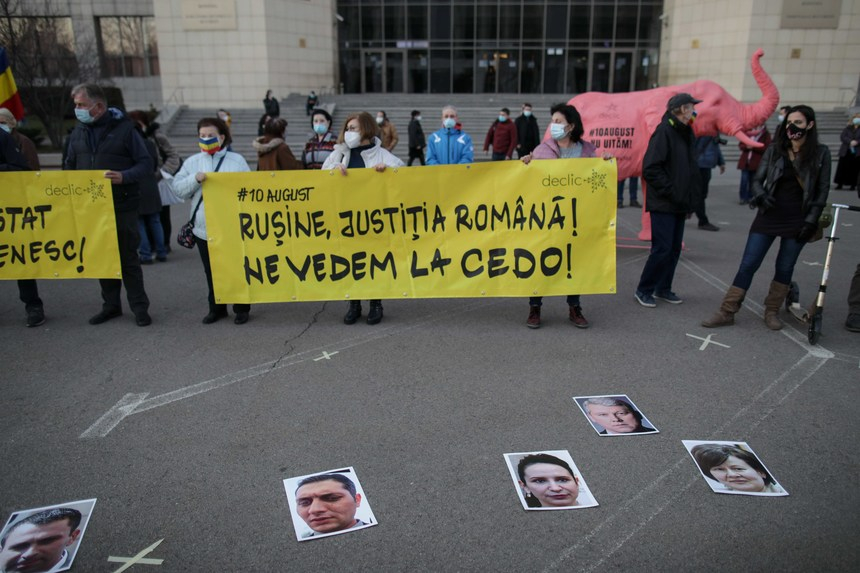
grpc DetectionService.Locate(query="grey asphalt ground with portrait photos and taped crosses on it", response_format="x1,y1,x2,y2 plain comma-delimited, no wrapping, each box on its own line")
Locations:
0,169,860,572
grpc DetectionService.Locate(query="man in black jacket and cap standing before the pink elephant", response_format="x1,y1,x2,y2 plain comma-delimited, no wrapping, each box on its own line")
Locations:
635,93,701,308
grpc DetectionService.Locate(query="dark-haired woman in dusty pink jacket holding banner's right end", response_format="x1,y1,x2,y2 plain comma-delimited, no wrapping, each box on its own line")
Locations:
522,103,597,328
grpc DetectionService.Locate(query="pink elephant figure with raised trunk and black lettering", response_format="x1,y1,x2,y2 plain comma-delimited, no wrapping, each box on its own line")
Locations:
568,49,779,180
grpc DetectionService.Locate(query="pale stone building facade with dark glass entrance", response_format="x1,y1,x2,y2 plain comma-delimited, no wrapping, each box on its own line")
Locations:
6,0,860,109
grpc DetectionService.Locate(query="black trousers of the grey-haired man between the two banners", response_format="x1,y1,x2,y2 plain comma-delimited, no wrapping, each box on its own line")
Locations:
99,210,149,313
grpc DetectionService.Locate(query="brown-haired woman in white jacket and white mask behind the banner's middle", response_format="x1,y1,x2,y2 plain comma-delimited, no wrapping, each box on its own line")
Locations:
322,111,403,324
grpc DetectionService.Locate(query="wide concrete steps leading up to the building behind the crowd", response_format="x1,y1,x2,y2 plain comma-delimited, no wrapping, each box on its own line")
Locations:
161,94,848,169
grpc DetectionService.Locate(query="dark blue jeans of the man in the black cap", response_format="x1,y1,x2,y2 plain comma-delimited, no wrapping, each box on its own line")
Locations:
636,211,687,294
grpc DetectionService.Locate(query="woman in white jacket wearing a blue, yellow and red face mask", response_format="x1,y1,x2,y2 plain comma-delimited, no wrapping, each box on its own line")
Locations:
173,117,251,324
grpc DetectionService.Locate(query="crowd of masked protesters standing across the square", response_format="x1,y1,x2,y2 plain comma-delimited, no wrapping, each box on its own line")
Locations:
0,84,860,332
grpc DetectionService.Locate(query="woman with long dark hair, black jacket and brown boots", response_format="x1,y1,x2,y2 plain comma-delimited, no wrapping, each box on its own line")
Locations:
702,105,831,330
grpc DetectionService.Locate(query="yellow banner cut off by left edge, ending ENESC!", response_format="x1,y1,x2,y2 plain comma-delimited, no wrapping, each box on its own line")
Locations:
0,171,122,280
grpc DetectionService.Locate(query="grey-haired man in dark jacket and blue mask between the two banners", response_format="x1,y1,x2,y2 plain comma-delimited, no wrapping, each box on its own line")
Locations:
63,84,155,326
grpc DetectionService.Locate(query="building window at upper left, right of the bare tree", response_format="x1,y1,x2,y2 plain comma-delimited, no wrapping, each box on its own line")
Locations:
96,16,160,78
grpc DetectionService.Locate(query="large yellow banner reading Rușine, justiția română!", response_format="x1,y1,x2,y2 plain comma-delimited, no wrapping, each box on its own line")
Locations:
203,159,617,303
